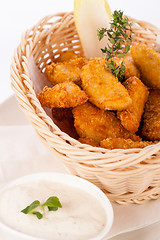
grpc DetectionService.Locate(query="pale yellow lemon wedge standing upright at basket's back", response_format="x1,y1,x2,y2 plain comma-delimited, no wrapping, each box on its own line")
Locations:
74,0,112,58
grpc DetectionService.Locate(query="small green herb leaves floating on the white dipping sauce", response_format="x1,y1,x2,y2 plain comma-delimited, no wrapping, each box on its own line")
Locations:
21,197,62,219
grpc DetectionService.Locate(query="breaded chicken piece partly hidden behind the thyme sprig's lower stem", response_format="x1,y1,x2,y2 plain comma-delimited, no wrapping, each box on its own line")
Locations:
114,56,140,79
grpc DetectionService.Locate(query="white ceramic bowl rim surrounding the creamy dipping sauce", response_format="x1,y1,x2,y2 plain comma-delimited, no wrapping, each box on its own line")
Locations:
0,172,113,240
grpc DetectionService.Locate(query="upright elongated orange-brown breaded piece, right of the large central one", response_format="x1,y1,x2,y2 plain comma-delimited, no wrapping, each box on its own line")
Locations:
117,77,149,132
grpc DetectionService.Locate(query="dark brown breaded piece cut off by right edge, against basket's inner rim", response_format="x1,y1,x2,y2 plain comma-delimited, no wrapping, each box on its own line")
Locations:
142,89,160,141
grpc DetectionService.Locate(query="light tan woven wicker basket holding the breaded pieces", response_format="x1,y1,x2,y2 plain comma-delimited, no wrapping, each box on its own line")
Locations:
11,10,160,204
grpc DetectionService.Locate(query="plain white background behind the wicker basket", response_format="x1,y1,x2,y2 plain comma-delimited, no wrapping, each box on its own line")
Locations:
0,0,160,103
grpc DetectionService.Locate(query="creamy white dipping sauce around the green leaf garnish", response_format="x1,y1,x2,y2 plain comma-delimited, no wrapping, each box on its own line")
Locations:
0,180,107,240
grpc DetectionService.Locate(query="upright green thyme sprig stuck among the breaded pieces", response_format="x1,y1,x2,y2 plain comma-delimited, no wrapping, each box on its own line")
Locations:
97,10,133,82
